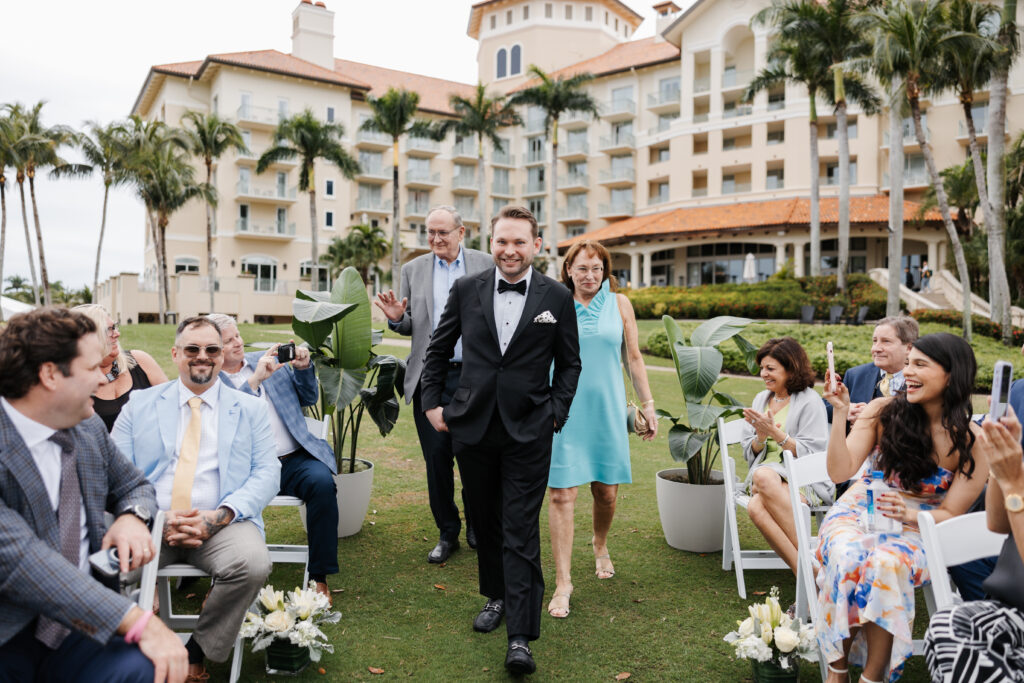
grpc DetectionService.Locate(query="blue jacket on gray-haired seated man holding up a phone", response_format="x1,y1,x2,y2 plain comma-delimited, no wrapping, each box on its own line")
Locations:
220,351,338,474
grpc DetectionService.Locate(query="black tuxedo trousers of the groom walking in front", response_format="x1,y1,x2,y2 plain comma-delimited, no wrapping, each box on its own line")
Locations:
453,410,554,640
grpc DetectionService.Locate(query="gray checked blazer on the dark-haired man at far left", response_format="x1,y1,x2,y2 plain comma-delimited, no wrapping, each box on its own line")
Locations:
0,408,157,645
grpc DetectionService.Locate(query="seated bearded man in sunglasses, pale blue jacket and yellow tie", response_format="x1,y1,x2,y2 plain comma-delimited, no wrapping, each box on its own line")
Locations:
111,316,281,680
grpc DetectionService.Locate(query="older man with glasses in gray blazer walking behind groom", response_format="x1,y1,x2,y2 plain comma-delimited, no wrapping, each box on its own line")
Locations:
374,206,494,564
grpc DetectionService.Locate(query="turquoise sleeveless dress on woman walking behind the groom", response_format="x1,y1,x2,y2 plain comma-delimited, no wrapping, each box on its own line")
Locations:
548,280,633,488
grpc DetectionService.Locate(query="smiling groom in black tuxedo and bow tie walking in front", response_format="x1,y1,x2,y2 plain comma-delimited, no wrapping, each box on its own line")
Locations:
420,206,581,674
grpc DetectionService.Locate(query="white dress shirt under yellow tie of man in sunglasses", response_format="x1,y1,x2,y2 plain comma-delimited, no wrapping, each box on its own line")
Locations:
153,378,224,517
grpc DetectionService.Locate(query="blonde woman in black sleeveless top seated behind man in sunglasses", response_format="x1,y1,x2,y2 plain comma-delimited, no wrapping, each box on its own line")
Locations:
75,303,167,431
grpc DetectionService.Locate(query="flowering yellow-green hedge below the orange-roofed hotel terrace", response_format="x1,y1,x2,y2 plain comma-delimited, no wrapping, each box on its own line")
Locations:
623,273,886,319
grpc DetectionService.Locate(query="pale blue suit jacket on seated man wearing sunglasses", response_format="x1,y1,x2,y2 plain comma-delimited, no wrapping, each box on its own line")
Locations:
111,381,281,530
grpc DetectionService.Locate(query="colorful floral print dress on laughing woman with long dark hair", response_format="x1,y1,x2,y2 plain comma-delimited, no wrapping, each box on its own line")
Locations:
817,447,953,681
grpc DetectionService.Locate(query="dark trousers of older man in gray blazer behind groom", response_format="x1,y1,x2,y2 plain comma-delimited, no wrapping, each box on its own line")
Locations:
413,368,471,543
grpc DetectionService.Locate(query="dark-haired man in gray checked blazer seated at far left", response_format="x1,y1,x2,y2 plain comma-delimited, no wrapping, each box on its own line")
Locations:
0,308,187,683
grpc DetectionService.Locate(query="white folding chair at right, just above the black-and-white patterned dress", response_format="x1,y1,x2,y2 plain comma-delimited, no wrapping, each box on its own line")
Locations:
918,511,1007,614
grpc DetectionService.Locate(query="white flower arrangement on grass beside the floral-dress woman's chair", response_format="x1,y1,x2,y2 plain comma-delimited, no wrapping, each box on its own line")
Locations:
724,586,818,670
